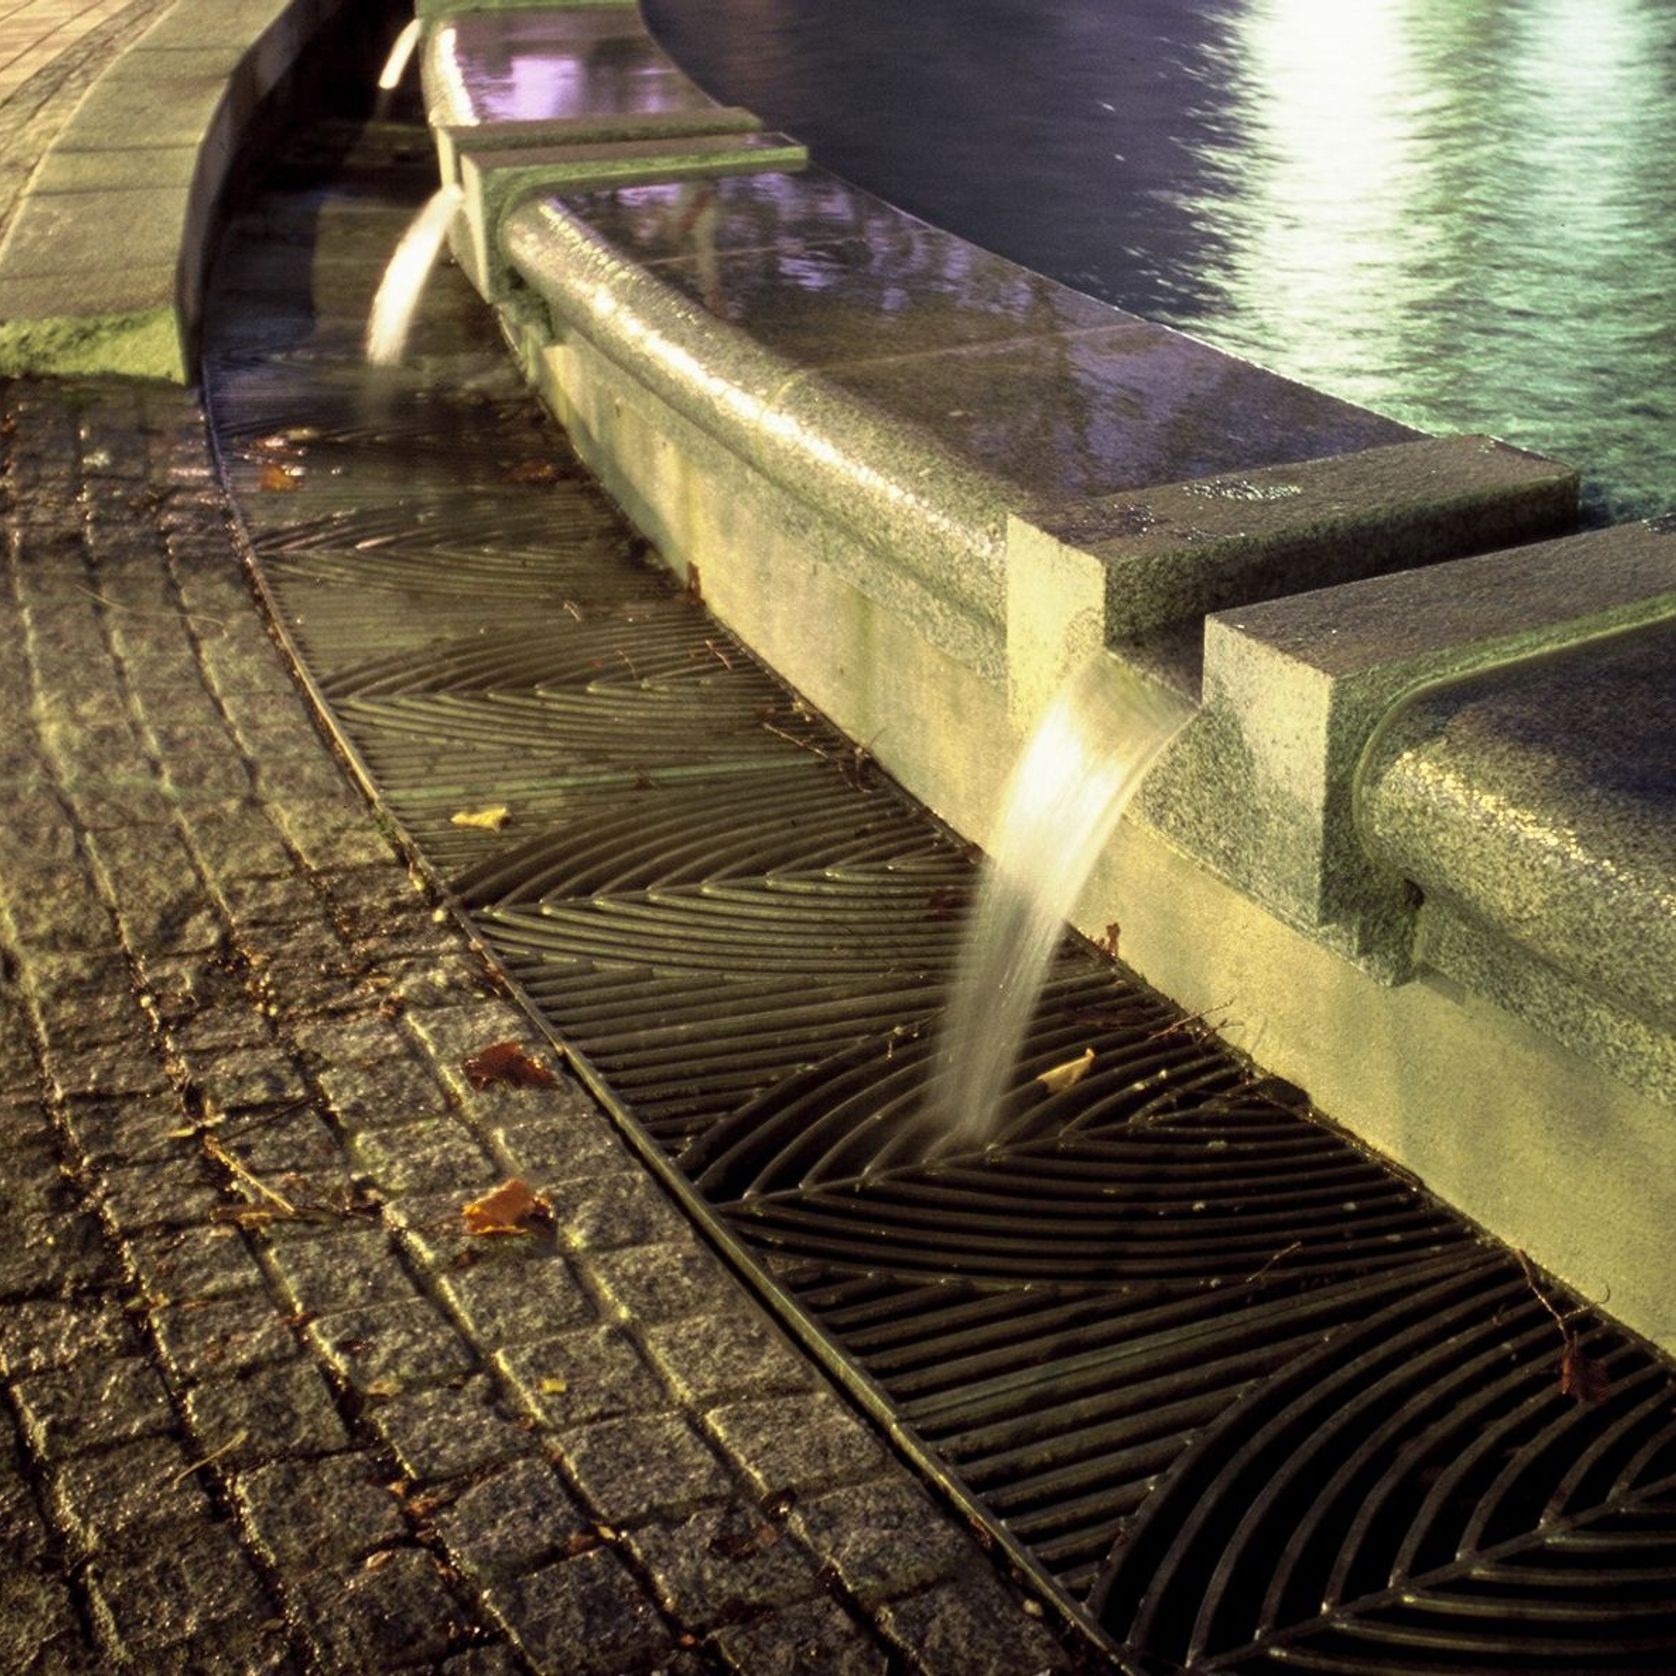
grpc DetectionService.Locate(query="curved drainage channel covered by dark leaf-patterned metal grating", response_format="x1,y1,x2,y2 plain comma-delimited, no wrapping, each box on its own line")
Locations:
204,88,1676,1676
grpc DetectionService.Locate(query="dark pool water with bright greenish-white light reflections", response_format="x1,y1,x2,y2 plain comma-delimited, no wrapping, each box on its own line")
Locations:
645,0,1676,518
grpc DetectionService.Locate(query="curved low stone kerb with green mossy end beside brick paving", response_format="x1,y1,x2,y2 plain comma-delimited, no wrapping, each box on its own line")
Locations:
0,0,360,384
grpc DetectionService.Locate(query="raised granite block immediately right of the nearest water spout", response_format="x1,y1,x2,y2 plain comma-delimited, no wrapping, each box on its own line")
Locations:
1141,525,1676,979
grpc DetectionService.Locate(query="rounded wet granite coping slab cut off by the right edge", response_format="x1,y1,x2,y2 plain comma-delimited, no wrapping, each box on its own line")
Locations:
1358,623,1676,1072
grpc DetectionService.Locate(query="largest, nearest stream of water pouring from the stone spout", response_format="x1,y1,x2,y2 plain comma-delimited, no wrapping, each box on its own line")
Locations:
929,652,1190,1151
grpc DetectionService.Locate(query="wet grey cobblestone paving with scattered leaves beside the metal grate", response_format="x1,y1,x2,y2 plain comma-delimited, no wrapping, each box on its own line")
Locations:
0,382,1073,1676
